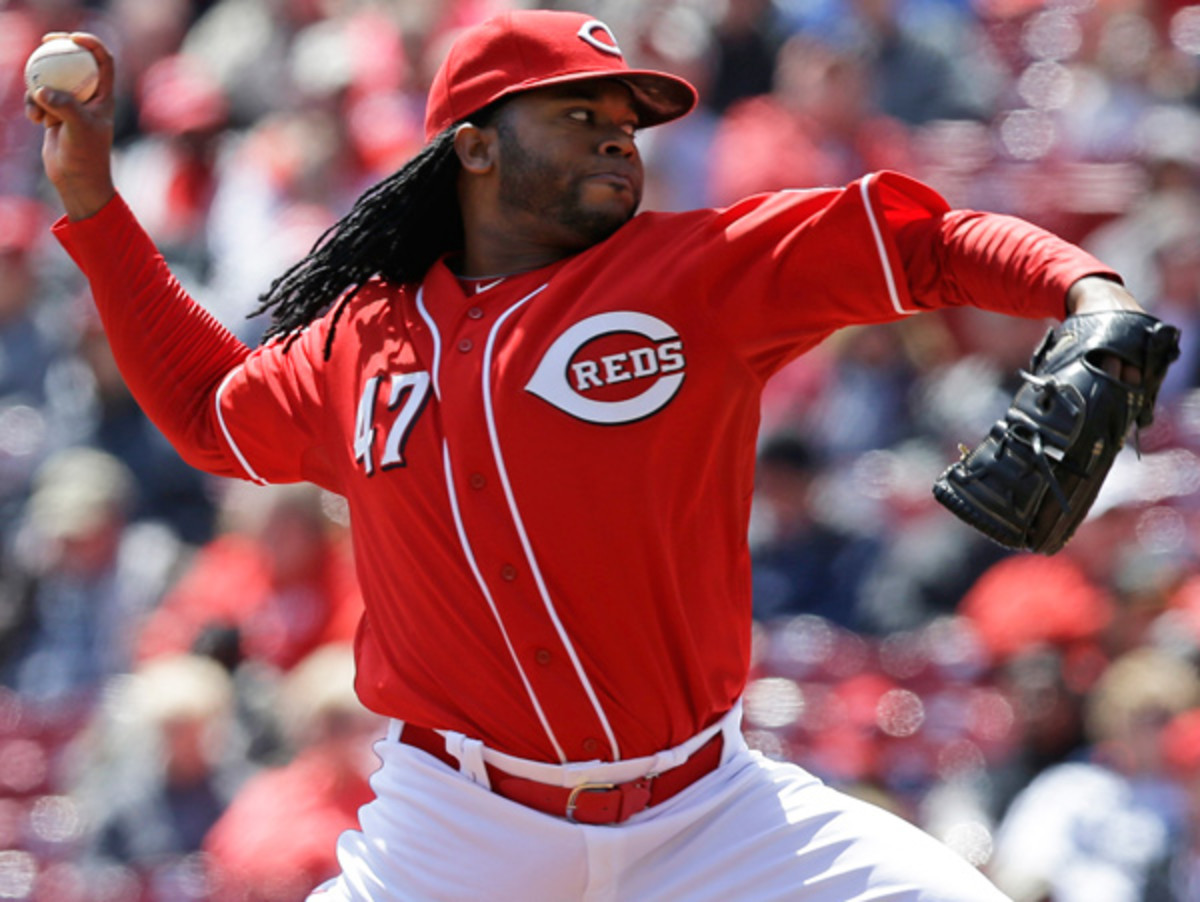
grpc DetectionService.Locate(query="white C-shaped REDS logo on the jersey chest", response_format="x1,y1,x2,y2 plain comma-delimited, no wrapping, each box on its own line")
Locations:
526,311,686,426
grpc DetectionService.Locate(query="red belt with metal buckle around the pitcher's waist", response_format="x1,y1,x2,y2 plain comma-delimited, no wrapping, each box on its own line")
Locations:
400,723,722,824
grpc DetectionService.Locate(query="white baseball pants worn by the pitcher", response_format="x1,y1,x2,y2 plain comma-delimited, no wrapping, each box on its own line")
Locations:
310,717,1006,902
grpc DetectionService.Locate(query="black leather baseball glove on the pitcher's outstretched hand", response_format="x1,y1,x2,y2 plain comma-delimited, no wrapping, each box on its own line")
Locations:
934,311,1180,554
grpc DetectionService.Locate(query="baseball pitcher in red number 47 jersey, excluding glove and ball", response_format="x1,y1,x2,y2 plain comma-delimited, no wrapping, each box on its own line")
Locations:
28,11,1152,902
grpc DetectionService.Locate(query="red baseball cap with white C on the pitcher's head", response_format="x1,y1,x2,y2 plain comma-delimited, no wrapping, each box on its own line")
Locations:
425,10,696,140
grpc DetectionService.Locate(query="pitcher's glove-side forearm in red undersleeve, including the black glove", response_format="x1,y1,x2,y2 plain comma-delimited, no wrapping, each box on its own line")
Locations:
912,190,1178,554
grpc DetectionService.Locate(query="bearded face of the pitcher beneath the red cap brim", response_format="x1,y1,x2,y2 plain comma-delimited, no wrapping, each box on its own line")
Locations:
497,80,643,249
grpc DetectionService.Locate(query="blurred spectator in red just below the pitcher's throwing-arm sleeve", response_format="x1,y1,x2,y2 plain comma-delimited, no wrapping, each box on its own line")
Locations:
138,483,361,671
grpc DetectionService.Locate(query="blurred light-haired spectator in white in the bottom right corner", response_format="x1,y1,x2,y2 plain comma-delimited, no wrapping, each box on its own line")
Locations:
990,648,1200,902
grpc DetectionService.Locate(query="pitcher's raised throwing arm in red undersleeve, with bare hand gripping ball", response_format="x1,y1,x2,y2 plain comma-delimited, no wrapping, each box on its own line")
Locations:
25,32,282,476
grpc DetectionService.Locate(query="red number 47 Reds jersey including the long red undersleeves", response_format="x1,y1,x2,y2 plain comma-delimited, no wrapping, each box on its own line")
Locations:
58,167,1109,762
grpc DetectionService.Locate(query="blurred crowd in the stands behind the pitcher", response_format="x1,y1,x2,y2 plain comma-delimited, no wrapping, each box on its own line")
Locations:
0,0,1200,902
